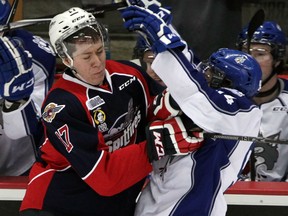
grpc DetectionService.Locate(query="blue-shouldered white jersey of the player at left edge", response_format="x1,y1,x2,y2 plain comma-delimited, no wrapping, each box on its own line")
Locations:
0,30,56,176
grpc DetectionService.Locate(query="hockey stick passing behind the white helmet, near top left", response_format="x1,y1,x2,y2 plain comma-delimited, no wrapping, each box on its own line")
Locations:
0,1,127,32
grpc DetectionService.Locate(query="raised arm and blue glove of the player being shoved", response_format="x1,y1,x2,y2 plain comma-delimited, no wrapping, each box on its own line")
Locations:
121,6,260,134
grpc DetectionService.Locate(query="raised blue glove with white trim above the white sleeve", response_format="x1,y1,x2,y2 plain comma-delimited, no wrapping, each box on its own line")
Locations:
120,6,185,53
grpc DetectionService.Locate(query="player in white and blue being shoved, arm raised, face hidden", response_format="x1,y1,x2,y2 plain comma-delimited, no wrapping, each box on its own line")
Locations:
121,1,262,216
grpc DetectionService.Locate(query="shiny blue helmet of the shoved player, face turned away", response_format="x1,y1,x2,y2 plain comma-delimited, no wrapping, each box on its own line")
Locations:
208,48,262,97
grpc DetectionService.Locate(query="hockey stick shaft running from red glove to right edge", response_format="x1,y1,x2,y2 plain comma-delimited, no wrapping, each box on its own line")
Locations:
204,133,288,145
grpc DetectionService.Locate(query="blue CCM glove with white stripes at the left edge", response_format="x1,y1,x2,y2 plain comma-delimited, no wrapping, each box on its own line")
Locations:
0,37,34,101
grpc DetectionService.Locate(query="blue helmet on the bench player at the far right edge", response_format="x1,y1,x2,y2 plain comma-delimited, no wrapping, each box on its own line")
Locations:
236,21,286,60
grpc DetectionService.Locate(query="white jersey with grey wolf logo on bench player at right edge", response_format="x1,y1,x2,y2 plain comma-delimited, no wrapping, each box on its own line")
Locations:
254,78,288,181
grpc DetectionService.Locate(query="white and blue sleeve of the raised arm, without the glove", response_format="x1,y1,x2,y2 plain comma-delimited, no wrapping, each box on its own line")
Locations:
152,50,262,136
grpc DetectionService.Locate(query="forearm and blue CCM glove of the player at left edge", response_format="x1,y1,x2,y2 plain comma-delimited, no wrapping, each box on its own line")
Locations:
0,37,38,139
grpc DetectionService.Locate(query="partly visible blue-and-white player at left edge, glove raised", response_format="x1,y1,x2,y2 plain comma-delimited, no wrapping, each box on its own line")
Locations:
0,0,56,176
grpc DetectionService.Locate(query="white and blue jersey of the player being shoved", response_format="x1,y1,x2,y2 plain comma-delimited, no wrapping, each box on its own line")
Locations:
135,50,262,216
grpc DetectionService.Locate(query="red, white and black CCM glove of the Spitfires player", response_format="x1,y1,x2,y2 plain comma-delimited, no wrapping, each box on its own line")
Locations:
146,116,204,162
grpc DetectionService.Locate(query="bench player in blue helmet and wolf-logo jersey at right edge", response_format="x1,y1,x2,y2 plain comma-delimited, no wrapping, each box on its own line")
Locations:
237,21,288,181
